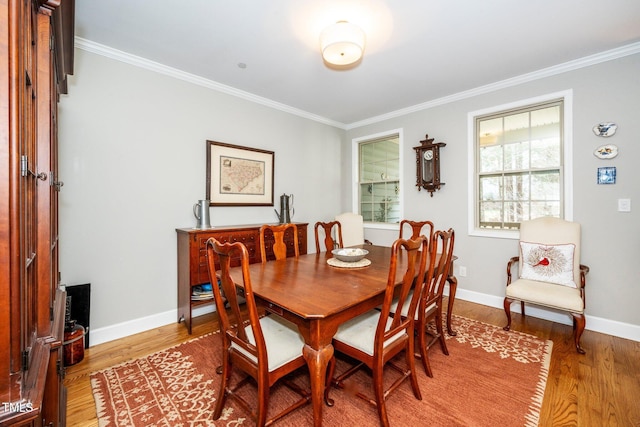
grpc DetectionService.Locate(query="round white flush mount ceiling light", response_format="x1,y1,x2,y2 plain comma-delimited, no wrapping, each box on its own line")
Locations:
320,21,364,66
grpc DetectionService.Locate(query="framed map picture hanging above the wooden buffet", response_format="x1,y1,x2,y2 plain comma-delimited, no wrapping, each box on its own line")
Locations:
206,141,274,206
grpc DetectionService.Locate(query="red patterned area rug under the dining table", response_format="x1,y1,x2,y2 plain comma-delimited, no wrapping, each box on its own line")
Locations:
91,316,552,427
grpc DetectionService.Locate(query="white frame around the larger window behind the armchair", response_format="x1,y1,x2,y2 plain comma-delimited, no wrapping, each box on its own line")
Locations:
467,90,573,240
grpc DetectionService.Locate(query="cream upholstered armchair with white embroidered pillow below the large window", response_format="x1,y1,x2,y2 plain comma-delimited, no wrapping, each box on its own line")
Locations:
504,217,589,354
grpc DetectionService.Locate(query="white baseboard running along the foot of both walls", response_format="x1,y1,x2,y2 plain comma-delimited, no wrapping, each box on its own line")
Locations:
91,288,640,347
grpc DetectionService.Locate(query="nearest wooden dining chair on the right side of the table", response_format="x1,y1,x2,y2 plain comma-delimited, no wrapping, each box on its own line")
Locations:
325,236,428,426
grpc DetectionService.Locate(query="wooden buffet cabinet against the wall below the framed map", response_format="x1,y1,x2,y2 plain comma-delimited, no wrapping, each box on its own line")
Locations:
176,222,309,333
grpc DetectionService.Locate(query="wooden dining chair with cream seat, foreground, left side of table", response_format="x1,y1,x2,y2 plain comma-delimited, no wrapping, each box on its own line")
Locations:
207,237,311,426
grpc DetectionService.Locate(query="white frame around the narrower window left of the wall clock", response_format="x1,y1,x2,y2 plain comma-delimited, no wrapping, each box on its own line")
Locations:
351,128,404,230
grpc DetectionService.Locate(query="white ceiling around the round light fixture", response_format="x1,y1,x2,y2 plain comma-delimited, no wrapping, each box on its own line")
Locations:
75,0,640,127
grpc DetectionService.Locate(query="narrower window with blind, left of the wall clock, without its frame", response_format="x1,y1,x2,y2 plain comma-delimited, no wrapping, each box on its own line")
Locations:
354,132,400,224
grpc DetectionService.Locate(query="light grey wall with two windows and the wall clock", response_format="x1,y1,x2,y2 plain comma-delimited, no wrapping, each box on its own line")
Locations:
350,55,640,340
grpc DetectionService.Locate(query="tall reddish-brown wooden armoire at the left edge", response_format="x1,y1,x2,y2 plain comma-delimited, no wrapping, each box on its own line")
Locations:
0,0,74,426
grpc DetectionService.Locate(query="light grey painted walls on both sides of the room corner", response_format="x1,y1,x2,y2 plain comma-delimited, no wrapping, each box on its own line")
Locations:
59,49,640,344
